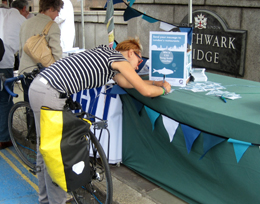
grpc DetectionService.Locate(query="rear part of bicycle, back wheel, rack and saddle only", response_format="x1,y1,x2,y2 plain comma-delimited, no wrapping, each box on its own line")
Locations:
68,98,113,204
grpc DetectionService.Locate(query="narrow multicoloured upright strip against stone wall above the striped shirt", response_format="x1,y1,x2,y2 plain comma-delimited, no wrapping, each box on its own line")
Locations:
105,0,114,47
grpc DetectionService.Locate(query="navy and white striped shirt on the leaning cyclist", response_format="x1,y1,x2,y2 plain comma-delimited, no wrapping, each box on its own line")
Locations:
40,45,126,95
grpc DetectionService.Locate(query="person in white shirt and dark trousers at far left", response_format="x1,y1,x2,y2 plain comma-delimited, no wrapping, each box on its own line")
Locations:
0,5,26,149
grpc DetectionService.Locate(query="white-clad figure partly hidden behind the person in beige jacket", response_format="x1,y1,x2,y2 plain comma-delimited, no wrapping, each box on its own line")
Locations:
55,0,75,52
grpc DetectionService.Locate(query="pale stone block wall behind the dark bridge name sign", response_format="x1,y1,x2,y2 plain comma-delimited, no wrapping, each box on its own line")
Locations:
31,0,260,81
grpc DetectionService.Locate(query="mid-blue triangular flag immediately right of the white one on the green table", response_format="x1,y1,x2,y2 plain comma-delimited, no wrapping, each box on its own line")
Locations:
181,124,200,153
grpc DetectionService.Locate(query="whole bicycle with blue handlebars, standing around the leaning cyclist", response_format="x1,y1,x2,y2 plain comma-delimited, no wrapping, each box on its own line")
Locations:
1,72,113,204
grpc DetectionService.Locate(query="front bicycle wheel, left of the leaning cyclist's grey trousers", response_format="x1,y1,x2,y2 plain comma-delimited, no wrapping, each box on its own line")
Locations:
8,101,37,170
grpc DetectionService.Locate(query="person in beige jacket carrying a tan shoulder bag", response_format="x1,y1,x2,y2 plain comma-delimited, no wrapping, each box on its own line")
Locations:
18,0,63,102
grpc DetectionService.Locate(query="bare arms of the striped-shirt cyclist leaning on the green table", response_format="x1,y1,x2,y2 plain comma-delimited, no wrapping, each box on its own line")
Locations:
112,61,171,97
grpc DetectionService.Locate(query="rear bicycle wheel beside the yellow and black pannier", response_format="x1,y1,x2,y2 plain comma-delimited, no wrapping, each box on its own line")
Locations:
72,132,113,204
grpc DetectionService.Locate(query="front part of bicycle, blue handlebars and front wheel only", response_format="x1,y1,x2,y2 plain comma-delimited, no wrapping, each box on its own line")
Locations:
1,68,40,174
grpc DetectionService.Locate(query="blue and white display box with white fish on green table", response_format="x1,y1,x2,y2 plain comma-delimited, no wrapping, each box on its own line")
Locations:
149,31,191,86
